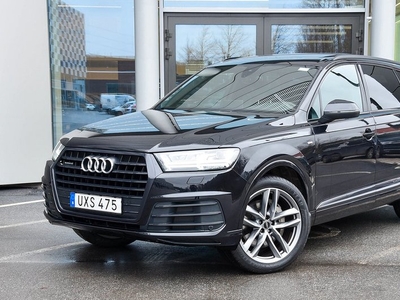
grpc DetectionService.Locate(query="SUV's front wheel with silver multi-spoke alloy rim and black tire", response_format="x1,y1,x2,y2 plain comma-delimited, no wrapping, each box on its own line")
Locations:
224,177,311,274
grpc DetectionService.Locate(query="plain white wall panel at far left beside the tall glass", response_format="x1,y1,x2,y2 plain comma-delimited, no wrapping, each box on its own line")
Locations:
0,0,52,185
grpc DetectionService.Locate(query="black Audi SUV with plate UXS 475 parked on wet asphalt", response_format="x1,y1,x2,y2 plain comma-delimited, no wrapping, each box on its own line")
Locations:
42,54,400,273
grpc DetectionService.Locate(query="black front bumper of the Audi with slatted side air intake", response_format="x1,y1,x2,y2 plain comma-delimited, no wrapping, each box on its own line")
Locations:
42,161,246,247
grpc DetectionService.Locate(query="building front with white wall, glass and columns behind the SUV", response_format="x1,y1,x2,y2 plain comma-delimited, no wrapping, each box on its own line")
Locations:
0,0,400,186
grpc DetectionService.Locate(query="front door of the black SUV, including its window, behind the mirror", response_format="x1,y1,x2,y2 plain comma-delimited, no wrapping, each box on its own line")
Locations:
309,64,376,219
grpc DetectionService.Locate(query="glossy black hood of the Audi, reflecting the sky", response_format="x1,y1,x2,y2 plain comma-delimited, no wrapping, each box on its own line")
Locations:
64,110,294,152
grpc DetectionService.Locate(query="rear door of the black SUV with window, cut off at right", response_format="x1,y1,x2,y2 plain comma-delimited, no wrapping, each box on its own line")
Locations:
361,64,400,193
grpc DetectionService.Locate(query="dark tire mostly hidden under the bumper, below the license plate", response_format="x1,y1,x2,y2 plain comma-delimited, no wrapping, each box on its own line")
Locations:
74,229,135,248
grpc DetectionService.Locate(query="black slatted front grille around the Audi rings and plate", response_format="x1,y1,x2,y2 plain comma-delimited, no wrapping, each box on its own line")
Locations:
54,150,148,221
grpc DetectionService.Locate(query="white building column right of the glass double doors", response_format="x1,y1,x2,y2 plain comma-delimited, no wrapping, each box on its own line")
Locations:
371,0,396,59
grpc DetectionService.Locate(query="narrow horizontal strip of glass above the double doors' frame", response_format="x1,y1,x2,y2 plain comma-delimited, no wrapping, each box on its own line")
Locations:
164,0,364,9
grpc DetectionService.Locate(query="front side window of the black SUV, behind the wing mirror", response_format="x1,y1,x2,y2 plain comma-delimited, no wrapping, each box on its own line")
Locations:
308,65,363,120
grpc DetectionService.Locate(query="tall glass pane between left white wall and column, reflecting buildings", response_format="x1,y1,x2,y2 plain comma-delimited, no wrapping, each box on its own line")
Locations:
48,0,135,143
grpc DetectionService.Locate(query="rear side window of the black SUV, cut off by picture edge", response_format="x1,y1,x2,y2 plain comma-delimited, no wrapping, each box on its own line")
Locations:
361,65,400,110
